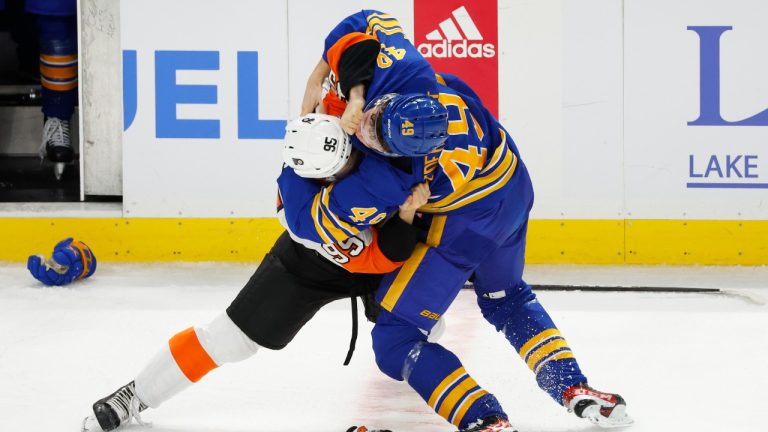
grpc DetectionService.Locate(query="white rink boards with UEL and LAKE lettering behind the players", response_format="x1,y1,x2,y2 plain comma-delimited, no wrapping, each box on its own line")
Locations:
114,0,768,223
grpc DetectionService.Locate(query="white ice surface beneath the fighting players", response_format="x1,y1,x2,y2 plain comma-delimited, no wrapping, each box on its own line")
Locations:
0,263,768,432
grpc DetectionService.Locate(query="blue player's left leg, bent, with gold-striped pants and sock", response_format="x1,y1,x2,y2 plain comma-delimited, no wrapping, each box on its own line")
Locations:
371,243,511,430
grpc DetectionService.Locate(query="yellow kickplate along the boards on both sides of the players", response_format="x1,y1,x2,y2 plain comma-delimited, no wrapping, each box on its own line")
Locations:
0,218,768,265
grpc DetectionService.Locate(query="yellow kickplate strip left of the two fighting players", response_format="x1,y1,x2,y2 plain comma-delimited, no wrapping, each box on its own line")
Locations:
0,218,283,263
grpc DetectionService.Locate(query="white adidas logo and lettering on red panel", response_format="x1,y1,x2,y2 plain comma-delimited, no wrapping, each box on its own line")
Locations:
417,6,496,58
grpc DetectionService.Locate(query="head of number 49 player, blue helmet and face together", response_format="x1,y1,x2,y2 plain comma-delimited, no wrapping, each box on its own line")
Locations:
357,93,448,157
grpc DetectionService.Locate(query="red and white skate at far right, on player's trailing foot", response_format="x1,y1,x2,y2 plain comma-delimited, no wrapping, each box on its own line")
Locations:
563,384,634,428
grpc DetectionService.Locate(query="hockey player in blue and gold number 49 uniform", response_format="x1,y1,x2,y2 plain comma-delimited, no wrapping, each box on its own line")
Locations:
278,10,631,432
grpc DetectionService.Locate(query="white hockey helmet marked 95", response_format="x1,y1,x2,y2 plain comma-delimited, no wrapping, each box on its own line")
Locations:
283,113,352,178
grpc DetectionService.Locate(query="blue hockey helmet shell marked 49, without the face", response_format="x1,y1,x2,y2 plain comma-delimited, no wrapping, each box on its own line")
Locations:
381,93,448,157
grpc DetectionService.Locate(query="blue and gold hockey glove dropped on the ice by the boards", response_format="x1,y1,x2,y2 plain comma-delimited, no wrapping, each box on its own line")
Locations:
27,238,96,286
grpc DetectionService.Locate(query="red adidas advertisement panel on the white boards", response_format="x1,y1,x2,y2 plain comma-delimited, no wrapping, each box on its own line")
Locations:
414,0,499,117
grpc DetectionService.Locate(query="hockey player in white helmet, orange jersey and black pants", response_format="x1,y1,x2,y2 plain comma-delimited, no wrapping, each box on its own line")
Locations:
83,114,435,432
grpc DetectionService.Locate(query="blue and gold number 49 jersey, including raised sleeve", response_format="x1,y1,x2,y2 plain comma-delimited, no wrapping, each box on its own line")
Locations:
278,10,520,243
